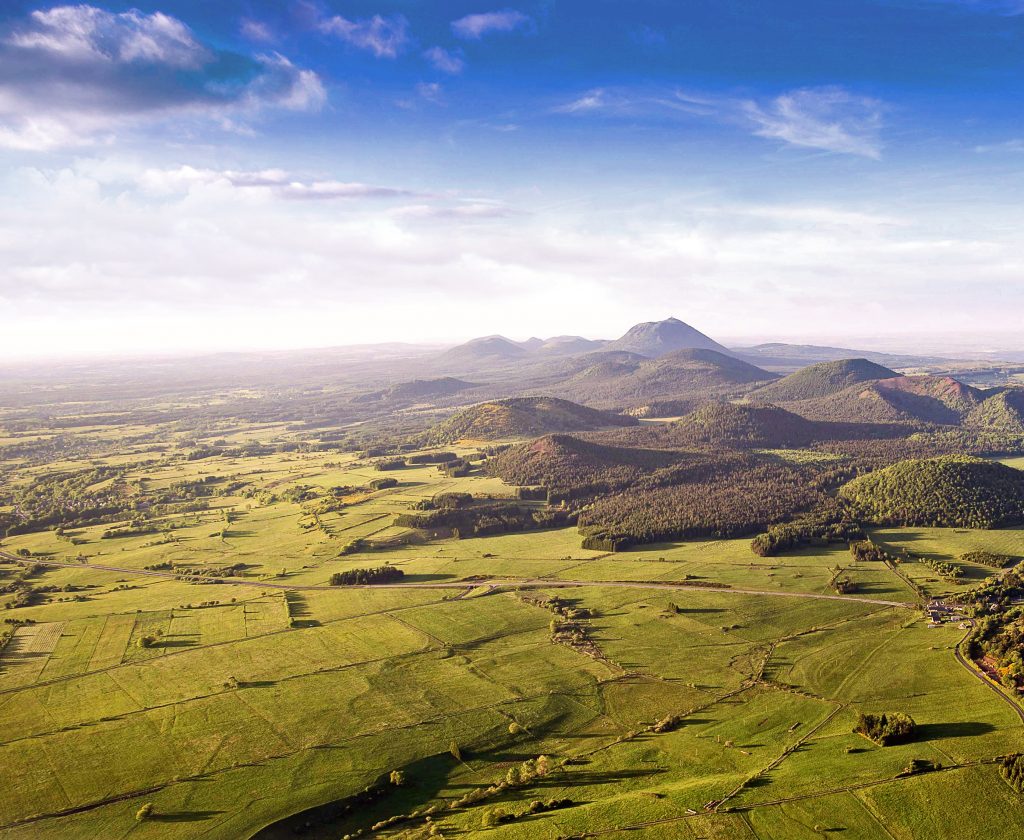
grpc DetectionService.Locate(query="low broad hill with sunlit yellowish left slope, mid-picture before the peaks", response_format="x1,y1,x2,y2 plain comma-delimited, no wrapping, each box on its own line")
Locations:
427,396,637,444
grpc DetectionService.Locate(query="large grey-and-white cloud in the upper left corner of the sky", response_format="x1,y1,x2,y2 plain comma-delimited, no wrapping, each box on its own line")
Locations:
0,5,326,150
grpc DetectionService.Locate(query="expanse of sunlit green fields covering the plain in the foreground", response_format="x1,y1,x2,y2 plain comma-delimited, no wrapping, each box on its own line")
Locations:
0,405,1024,840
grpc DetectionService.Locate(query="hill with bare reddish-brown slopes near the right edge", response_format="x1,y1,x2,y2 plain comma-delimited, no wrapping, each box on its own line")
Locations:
786,376,982,426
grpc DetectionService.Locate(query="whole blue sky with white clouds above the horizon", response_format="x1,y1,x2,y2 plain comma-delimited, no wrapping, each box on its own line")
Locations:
0,0,1024,359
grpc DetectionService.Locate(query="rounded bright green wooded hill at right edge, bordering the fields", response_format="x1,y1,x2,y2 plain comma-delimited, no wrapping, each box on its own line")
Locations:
840,455,1024,528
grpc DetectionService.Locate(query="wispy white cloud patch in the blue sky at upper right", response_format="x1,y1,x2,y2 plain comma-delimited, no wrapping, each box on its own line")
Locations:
742,87,883,160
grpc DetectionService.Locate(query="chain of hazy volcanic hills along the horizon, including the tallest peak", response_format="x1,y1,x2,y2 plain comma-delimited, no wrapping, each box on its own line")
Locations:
342,318,1024,439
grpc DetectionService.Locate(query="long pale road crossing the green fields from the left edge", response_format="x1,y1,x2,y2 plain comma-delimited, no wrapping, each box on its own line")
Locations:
0,551,918,607
